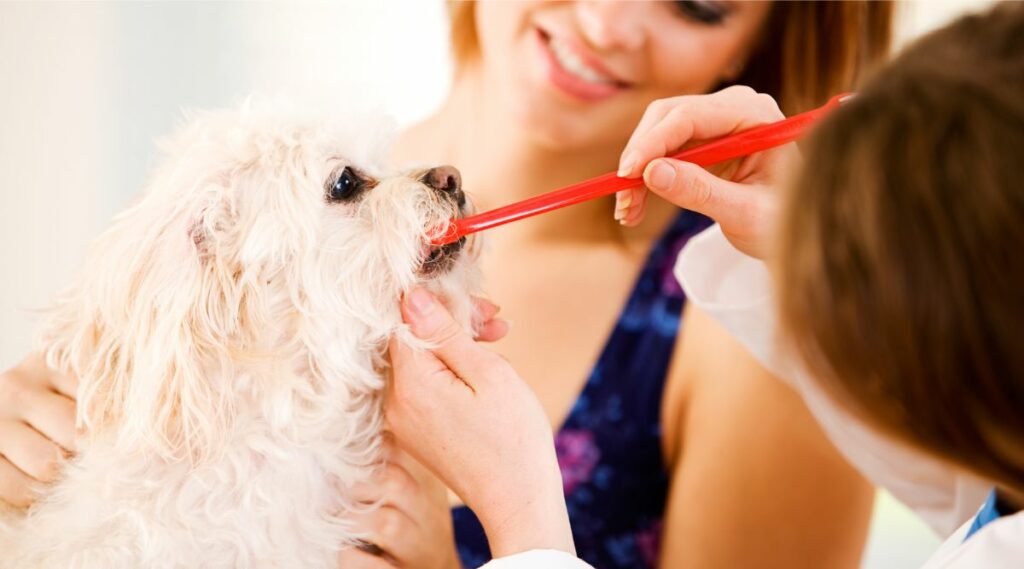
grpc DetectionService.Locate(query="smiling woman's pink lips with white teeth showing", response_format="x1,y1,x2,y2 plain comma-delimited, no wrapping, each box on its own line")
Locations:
535,28,626,101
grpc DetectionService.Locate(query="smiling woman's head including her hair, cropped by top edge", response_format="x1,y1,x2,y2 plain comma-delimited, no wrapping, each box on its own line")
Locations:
449,0,892,148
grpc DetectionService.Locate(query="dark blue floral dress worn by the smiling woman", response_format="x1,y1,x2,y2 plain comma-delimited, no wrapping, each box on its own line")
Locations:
453,211,712,569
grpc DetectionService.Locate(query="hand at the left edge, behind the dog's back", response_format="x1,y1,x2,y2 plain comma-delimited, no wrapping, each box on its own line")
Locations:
0,355,78,508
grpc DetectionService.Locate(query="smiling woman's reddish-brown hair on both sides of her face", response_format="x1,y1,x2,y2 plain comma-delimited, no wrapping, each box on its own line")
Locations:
447,0,893,115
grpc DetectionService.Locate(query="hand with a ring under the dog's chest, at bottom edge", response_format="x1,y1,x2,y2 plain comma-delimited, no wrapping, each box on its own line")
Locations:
338,441,461,569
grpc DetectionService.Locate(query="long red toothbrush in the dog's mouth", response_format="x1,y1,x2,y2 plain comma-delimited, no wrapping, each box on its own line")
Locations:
432,93,853,246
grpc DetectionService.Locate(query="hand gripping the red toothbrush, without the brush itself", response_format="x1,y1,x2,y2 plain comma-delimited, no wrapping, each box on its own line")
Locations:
615,86,799,259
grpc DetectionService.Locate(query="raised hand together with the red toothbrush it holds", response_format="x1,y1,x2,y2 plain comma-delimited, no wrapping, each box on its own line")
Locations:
431,87,852,257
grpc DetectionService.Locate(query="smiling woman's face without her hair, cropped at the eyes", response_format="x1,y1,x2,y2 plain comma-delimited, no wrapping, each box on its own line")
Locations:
474,1,771,151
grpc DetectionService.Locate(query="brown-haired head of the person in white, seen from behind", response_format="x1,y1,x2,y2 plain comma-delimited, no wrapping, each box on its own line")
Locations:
773,5,1024,492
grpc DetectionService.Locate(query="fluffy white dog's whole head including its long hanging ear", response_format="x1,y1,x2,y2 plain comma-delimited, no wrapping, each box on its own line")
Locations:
44,105,476,462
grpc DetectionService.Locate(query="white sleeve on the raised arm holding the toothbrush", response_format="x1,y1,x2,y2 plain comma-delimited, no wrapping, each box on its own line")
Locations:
675,225,990,536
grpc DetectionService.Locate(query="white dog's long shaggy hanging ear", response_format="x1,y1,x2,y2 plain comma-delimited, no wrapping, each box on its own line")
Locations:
42,182,270,463
